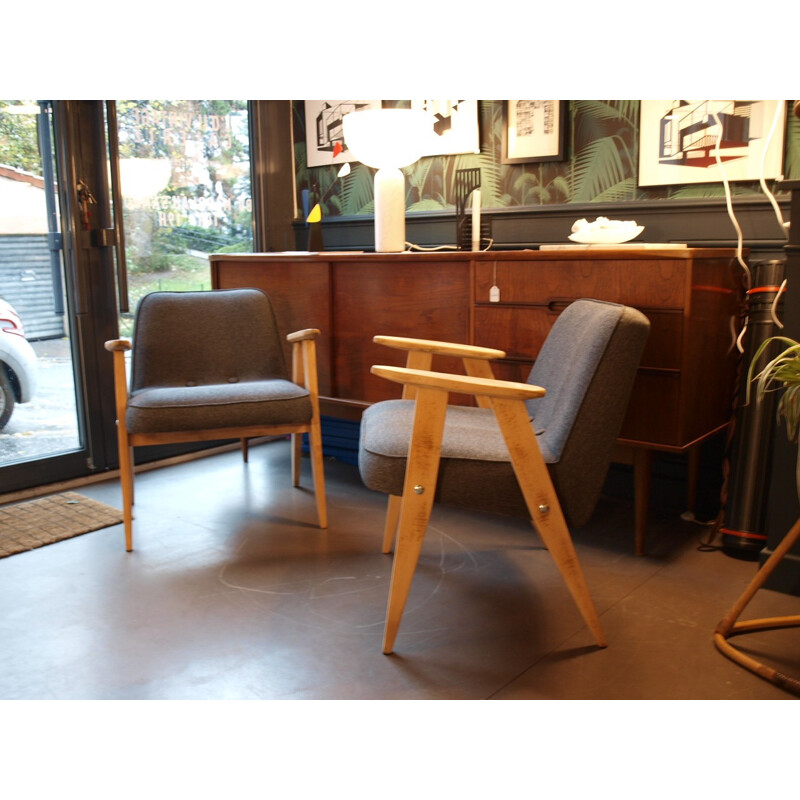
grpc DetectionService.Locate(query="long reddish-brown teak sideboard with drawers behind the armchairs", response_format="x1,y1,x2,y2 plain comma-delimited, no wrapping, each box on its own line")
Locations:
211,245,742,553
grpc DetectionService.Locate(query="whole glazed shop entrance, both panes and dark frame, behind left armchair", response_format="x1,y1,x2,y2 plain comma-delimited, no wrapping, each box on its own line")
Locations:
0,100,253,494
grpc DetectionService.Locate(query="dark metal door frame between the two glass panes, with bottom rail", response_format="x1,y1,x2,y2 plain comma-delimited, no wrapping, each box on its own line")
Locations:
0,100,118,493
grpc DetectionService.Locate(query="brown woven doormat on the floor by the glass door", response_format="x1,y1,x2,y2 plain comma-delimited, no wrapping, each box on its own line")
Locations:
0,492,122,558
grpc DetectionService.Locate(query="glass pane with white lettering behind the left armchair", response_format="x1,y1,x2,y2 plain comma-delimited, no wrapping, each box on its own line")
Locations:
109,100,253,336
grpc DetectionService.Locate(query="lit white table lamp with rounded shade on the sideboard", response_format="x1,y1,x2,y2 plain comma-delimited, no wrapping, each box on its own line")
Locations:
343,108,433,253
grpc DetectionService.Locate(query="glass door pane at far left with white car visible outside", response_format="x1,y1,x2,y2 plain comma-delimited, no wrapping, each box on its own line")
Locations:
0,100,89,491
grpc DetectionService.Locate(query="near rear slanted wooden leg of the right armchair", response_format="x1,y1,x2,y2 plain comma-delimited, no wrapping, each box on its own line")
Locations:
492,398,606,647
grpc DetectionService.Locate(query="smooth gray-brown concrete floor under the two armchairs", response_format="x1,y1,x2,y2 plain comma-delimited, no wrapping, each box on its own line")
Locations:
0,441,800,700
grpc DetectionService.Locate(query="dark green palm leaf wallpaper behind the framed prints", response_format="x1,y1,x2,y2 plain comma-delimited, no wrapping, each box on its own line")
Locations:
293,100,800,222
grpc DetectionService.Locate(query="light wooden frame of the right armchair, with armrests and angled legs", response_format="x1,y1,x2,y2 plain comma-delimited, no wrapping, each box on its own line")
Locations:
371,336,606,654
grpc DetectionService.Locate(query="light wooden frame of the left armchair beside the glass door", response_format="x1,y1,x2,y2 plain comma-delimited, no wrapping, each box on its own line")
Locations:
105,328,328,552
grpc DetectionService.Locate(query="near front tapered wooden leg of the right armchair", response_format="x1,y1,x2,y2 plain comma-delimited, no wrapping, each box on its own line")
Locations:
383,387,447,654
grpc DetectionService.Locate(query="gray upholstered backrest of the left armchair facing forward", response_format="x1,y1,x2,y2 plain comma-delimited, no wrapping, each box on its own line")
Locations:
131,289,289,391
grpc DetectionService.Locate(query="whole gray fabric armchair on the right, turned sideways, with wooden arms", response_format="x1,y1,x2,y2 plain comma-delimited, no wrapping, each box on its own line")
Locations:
359,299,649,653
